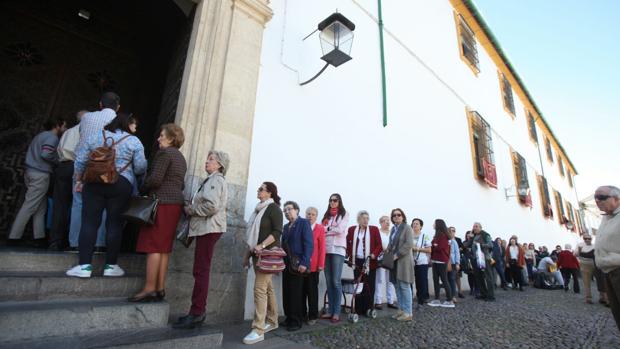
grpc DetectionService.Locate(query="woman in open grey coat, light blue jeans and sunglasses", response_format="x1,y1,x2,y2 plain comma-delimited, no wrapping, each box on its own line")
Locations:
388,208,414,322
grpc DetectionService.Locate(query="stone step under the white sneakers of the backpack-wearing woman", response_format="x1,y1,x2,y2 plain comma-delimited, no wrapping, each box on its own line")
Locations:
0,270,144,301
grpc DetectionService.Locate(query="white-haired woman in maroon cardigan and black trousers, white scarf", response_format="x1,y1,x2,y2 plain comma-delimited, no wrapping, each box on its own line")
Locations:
346,211,383,314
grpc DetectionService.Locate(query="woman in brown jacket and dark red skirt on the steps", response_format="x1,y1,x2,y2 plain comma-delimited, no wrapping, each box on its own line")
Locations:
129,124,187,302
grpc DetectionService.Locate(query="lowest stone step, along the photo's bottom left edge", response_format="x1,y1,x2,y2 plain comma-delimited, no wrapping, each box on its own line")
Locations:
0,327,223,349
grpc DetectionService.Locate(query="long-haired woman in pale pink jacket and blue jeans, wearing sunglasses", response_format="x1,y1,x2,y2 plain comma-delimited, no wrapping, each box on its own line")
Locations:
321,193,349,323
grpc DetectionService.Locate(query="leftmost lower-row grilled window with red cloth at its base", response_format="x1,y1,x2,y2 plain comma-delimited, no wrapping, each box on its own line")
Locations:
470,111,497,186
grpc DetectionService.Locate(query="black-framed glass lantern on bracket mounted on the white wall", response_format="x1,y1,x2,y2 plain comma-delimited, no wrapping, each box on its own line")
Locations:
300,12,355,86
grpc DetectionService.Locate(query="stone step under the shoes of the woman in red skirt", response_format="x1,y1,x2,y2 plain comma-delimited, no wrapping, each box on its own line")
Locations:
0,298,169,347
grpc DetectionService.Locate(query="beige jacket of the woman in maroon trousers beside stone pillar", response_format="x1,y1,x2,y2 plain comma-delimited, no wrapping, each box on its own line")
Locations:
189,172,228,236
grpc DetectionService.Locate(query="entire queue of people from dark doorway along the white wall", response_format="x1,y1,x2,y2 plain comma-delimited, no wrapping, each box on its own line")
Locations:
9,98,620,344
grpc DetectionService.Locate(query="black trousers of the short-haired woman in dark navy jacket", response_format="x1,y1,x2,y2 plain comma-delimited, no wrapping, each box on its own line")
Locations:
282,268,307,327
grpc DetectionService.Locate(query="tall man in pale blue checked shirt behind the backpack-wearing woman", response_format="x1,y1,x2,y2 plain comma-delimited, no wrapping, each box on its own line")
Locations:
69,92,121,251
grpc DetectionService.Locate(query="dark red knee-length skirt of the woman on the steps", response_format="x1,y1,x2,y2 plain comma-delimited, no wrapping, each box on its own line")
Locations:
136,204,183,253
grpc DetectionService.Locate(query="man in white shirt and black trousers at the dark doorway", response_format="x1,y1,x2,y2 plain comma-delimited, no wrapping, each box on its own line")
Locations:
49,110,88,251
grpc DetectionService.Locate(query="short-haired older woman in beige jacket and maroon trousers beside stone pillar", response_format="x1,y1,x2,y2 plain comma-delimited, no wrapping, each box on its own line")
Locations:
173,150,230,328
